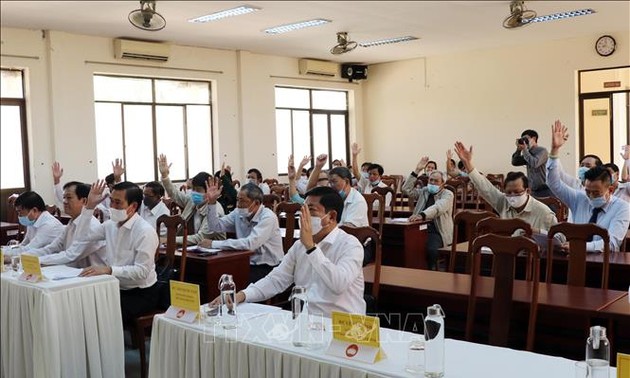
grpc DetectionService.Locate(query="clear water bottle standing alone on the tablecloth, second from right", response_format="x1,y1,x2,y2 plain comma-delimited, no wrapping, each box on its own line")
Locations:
424,305,446,378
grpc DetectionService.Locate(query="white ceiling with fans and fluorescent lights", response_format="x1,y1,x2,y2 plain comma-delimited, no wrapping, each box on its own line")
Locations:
0,0,630,64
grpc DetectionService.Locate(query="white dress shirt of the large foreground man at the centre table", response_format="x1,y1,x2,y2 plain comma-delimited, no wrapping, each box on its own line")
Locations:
243,228,366,317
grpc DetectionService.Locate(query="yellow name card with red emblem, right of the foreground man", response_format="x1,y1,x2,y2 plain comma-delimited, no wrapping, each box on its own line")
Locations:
327,311,385,363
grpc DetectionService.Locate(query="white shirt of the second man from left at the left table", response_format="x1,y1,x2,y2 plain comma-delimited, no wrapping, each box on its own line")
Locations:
29,215,106,268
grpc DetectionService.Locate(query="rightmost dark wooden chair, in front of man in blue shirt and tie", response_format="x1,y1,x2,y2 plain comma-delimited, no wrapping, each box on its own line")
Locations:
546,222,610,289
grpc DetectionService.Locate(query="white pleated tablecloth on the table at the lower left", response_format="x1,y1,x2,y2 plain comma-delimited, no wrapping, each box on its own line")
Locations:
0,267,125,378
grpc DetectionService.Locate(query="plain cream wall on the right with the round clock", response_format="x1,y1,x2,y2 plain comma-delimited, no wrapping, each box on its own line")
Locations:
361,32,630,174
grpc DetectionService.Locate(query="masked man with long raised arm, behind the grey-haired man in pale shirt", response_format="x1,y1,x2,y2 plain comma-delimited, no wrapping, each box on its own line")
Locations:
159,154,225,245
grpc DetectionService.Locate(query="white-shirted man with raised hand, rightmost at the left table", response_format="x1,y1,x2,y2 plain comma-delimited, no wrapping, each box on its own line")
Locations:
76,181,159,324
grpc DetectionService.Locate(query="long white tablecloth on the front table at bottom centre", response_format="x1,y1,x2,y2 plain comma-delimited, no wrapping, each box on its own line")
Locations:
149,306,615,378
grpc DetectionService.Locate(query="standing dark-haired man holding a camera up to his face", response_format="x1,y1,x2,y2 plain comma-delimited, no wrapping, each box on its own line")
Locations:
512,130,553,197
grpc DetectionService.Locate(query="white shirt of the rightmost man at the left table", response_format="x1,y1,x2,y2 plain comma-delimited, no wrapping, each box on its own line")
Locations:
76,208,160,290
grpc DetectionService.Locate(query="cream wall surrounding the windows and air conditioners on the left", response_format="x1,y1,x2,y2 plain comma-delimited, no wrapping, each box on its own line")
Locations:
0,28,362,202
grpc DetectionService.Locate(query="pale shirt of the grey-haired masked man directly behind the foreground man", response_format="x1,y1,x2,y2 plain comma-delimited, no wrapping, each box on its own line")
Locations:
206,204,284,266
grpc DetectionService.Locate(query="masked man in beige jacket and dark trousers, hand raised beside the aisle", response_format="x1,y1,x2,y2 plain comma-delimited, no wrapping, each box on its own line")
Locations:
402,168,454,270
